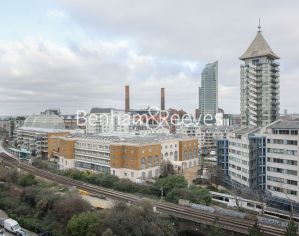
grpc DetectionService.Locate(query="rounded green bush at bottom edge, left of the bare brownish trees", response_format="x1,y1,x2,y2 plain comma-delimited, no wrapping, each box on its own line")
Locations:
66,211,105,236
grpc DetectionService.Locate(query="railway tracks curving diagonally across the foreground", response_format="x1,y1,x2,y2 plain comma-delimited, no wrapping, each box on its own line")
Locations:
0,153,284,236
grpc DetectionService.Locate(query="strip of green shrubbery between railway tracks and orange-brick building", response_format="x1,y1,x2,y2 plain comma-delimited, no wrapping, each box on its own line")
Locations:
33,161,212,205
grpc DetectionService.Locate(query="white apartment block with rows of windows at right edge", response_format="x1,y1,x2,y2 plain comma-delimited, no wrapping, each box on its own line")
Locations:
263,120,299,203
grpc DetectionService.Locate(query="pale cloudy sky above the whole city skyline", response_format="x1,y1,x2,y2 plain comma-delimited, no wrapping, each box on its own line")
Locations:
0,0,299,116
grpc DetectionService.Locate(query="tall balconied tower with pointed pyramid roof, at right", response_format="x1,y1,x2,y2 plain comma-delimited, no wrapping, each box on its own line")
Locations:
240,26,279,126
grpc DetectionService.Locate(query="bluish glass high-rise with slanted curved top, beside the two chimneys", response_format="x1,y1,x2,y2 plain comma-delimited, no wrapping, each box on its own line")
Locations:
200,61,218,115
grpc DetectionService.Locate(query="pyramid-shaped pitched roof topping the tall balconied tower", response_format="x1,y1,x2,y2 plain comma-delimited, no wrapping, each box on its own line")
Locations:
240,31,279,60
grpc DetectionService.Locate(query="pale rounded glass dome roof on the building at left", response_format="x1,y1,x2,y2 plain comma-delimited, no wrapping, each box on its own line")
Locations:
22,114,65,129
